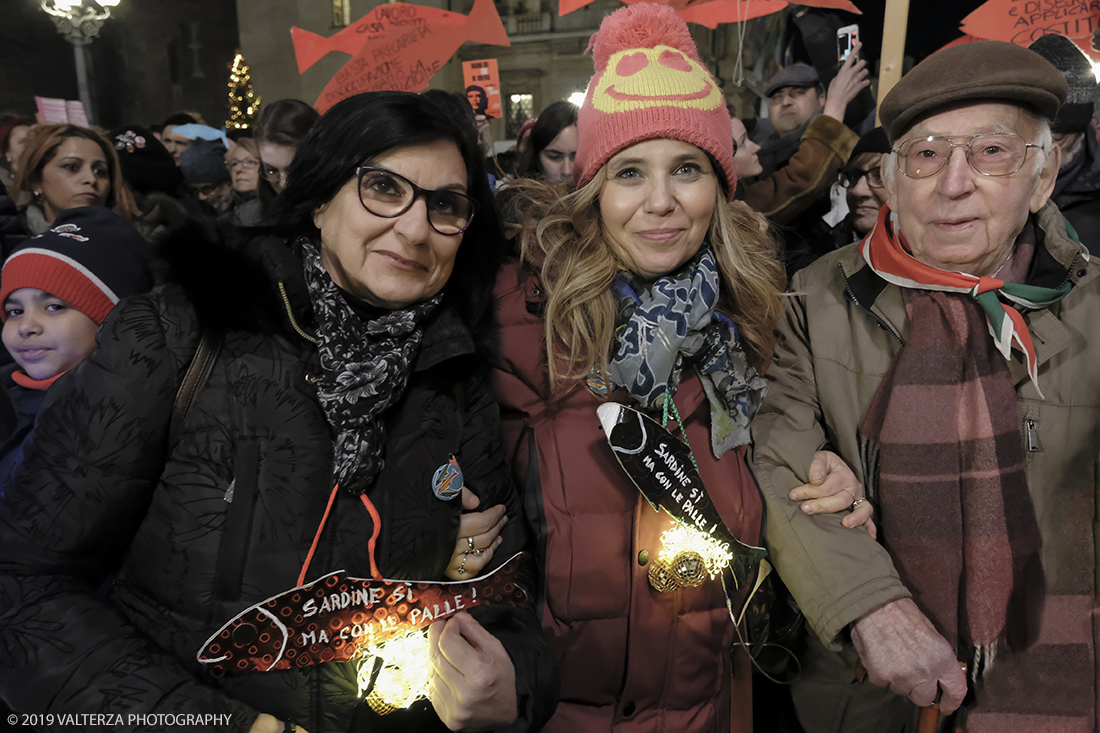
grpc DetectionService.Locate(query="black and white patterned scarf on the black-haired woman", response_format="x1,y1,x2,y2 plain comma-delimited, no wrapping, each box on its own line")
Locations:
301,242,443,494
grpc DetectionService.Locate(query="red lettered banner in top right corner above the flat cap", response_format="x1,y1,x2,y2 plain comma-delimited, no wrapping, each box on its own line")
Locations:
959,0,1100,56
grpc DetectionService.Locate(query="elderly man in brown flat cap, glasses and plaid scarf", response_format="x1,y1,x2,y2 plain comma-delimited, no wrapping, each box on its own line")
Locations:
752,42,1100,733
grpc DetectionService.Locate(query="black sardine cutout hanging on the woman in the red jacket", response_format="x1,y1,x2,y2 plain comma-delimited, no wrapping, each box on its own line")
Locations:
596,402,767,588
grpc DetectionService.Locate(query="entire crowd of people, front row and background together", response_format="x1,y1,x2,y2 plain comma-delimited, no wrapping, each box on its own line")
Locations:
0,3,1100,733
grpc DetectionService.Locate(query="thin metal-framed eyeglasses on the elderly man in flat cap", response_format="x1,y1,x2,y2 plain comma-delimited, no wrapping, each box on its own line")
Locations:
897,132,1040,178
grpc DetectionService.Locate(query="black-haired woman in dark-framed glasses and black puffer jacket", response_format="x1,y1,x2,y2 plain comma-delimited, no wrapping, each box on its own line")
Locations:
0,92,556,733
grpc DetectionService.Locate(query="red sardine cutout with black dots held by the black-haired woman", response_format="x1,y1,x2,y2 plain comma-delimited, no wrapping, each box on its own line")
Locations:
196,553,527,675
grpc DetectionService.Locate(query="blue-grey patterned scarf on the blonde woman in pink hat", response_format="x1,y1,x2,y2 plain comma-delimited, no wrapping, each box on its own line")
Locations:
608,245,767,458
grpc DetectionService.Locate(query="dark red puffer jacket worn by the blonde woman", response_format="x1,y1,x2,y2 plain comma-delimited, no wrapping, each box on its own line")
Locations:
492,266,761,733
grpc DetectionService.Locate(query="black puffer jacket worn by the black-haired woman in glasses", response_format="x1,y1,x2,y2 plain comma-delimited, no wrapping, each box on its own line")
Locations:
0,222,557,733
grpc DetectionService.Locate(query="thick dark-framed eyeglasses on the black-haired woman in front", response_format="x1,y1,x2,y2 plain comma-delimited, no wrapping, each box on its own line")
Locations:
355,165,477,236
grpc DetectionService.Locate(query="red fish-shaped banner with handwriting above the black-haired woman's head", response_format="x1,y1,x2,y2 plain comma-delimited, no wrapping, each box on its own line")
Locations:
290,0,510,114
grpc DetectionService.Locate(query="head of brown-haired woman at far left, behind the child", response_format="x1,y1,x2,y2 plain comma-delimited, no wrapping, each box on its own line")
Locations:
4,123,134,250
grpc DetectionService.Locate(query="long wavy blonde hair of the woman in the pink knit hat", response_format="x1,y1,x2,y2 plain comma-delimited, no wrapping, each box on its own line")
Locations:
516,166,787,392
